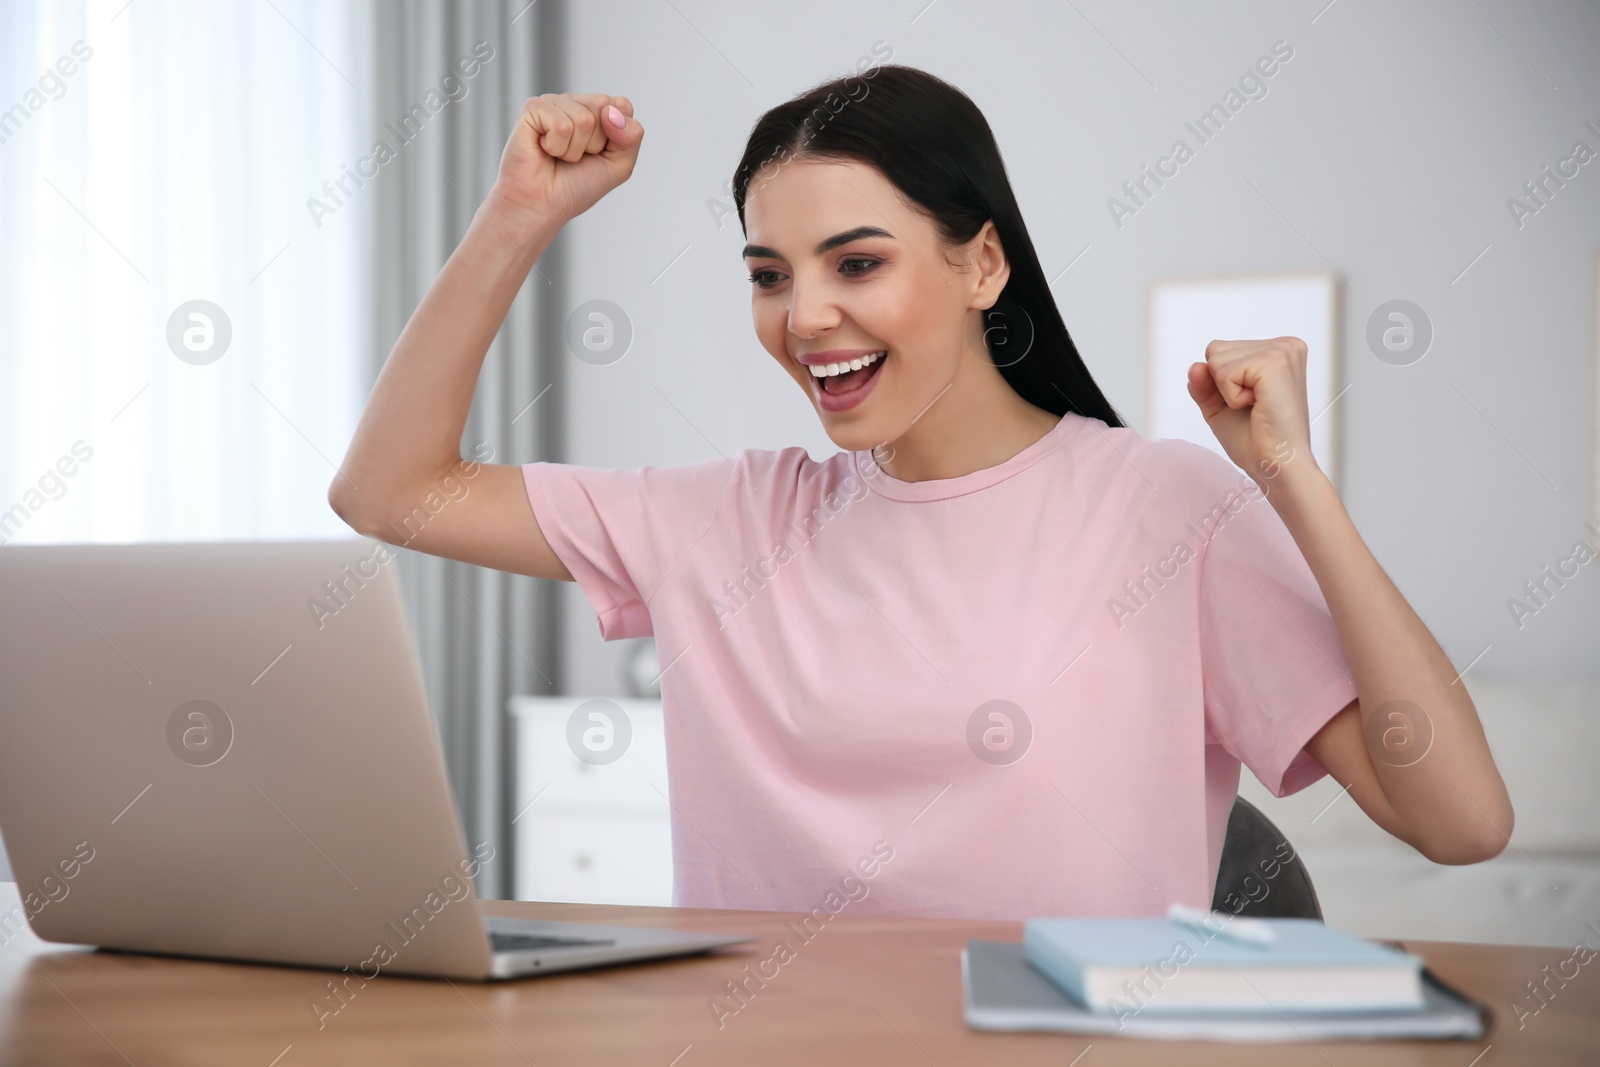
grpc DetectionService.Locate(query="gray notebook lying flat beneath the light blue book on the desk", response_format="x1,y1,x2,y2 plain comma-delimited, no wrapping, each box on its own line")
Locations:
962,939,1488,1041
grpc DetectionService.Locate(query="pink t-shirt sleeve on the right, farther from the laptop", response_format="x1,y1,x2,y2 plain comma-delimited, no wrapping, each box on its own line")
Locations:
1200,466,1357,797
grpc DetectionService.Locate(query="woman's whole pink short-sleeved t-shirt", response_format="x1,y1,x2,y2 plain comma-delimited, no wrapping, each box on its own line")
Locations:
523,413,1357,920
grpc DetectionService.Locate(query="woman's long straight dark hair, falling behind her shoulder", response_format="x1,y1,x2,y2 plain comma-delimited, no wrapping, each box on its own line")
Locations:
733,64,1125,426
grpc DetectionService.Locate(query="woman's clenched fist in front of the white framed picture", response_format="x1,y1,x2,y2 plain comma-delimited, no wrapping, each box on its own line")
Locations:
1189,338,1317,483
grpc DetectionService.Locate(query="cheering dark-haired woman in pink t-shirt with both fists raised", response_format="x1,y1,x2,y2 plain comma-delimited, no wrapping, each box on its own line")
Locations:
330,66,1512,920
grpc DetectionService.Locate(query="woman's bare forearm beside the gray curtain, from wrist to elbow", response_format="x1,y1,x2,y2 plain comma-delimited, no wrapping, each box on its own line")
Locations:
328,192,560,525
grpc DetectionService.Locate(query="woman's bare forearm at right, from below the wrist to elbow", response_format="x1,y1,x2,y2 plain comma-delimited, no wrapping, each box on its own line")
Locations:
1267,462,1512,862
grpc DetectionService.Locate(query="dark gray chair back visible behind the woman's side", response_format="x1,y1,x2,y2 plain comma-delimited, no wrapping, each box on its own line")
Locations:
1211,797,1322,920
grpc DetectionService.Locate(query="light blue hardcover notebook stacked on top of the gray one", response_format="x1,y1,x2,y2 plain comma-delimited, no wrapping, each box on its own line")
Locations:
1022,918,1426,1021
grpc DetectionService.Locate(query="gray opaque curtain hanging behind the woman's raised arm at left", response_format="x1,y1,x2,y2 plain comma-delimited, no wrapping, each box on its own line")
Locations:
363,0,566,897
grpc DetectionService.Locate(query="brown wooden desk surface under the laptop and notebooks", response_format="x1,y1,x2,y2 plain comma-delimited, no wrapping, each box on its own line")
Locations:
0,901,1600,1067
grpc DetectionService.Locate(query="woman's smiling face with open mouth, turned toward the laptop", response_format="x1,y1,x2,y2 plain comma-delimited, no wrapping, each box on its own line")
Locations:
744,160,1006,450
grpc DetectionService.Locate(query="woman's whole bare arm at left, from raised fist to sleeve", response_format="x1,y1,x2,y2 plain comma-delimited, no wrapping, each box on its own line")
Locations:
328,93,645,581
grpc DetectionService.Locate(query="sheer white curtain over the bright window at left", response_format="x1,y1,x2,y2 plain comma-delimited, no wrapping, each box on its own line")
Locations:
0,0,373,544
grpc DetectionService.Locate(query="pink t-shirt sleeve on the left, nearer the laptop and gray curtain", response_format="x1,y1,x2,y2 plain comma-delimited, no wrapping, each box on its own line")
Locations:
522,459,736,641
